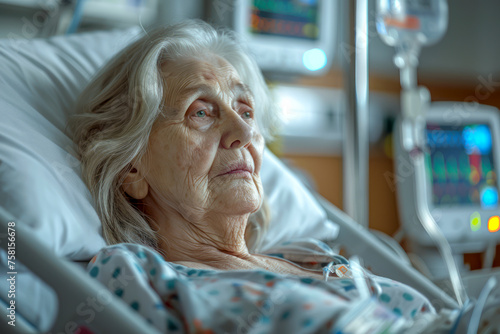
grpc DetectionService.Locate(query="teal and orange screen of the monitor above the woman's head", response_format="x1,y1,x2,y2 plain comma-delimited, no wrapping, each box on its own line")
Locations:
250,0,319,40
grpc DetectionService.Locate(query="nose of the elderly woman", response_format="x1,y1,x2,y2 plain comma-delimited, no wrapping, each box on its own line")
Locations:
221,110,254,149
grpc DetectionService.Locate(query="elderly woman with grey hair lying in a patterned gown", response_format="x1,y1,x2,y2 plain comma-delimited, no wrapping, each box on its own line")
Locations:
73,21,432,332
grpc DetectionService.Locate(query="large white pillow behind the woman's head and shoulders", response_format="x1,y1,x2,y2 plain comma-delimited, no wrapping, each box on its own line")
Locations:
0,28,337,260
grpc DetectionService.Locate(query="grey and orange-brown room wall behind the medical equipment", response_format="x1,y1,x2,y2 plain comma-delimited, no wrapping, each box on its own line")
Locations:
278,0,500,265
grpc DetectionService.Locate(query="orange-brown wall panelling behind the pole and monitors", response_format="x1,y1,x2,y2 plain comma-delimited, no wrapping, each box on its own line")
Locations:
282,70,500,268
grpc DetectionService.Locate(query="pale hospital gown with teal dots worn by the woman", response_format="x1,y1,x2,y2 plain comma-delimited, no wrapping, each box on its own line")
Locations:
87,238,433,334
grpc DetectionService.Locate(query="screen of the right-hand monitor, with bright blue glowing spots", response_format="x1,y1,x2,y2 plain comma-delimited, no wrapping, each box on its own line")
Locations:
426,124,498,209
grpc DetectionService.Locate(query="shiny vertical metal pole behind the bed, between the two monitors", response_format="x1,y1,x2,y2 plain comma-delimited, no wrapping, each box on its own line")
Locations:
341,0,369,228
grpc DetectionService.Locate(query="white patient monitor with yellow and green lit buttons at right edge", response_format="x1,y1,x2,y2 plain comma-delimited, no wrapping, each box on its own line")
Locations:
394,102,500,274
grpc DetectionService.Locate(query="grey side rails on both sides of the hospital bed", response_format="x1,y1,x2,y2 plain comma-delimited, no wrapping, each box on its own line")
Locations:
0,195,458,334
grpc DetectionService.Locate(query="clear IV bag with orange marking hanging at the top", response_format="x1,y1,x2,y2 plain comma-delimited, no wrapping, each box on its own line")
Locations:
376,0,448,50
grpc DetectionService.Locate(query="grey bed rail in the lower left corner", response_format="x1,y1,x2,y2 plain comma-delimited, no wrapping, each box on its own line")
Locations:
0,207,159,334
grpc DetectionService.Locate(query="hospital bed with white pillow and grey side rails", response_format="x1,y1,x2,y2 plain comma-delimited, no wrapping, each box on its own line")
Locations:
0,28,488,333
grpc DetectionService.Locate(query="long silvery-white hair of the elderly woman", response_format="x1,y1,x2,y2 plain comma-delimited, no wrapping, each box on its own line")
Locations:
71,20,279,251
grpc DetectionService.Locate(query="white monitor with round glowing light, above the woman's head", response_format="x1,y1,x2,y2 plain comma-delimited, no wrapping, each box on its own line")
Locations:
210,0,338,75
